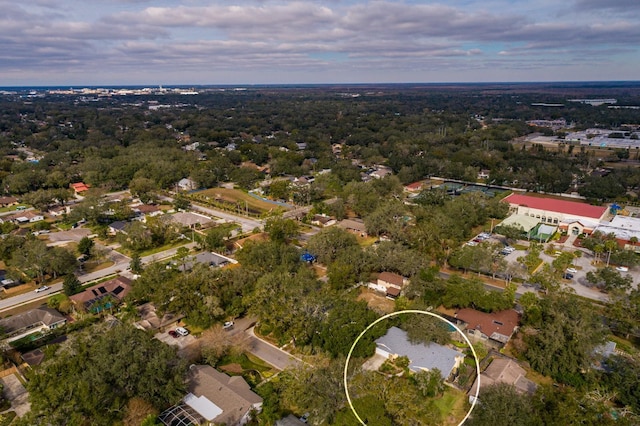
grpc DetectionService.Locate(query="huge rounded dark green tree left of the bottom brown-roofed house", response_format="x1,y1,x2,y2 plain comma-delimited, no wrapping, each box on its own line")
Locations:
26,324,185,425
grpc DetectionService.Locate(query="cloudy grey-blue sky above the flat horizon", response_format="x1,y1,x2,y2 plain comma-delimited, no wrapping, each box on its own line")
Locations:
0,0,640,86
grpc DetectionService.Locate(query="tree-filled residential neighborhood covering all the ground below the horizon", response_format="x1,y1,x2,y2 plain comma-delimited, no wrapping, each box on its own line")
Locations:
0,88,640,426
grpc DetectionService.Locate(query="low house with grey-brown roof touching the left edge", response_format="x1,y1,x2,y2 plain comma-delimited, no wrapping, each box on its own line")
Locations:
0,306,67,342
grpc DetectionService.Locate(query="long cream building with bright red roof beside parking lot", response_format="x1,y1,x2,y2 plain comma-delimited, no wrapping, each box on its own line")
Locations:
502,193,607,235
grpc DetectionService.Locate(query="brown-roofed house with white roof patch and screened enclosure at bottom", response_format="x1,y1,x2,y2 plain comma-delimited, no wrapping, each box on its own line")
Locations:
159,365,262,426
